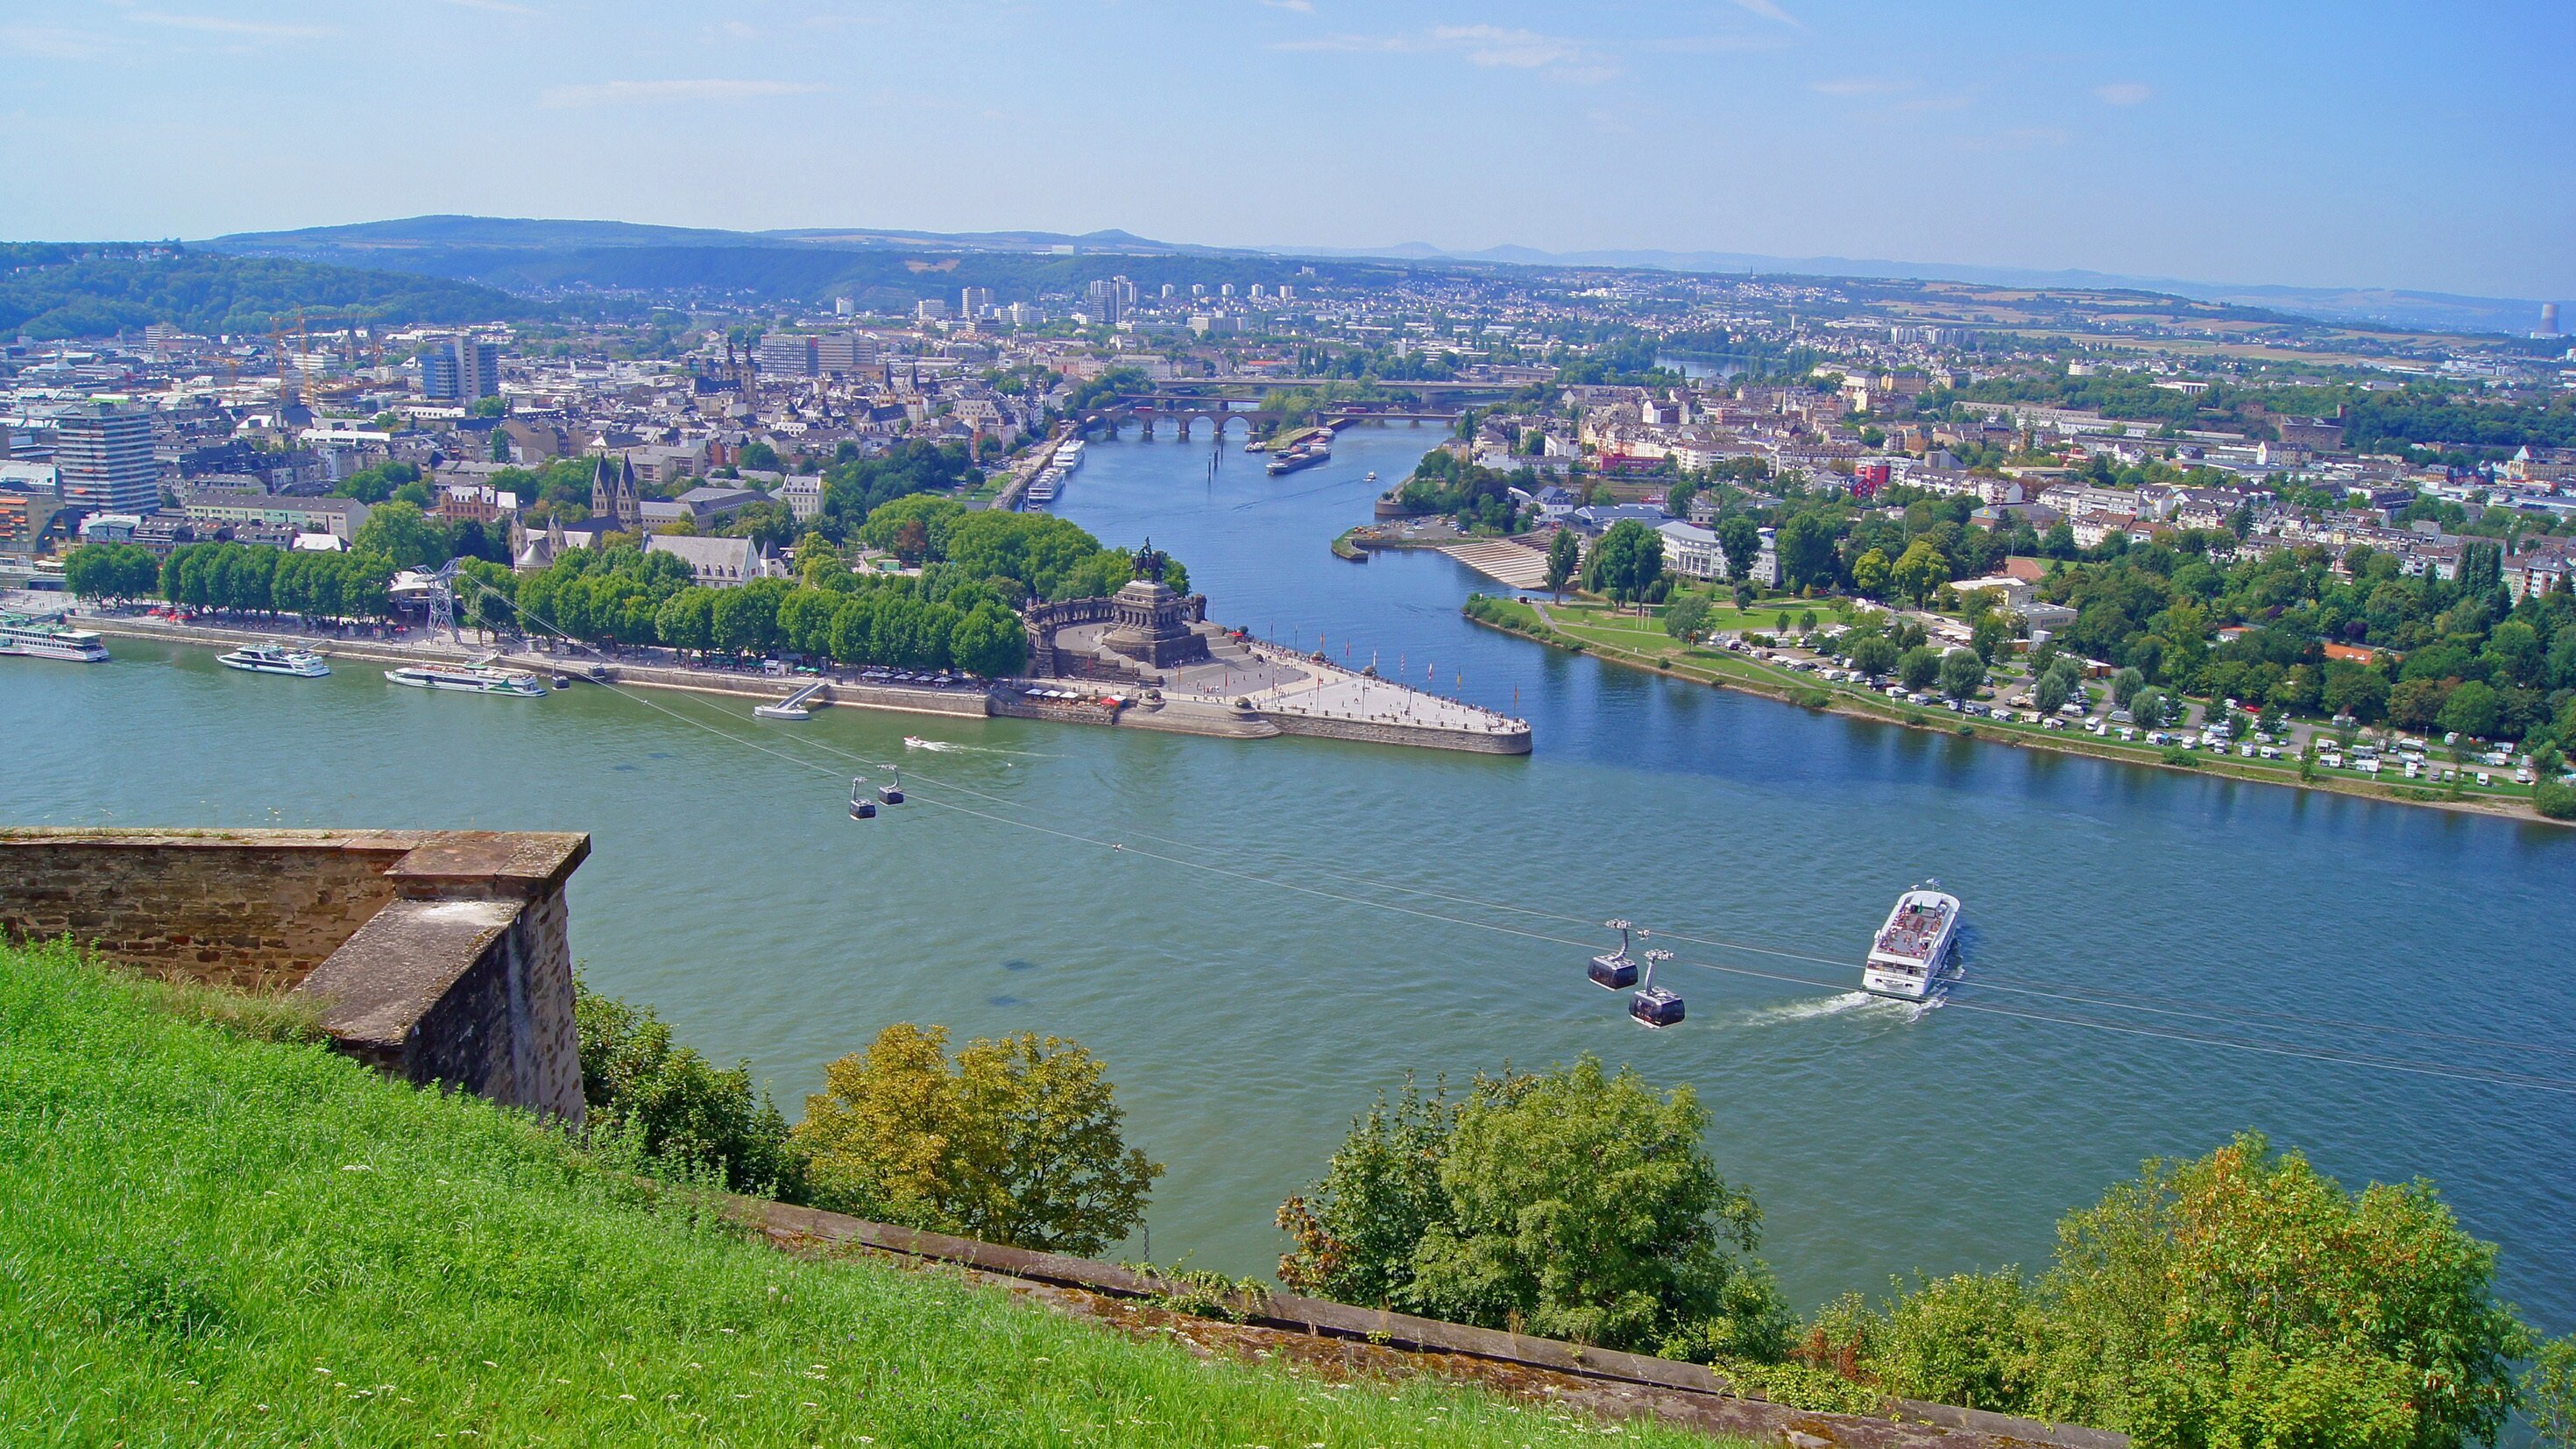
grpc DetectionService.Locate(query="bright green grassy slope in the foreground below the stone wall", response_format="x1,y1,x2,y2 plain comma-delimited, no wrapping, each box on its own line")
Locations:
0,947,1705,1446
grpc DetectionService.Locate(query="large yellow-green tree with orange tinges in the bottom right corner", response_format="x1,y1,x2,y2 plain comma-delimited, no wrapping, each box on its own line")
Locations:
2035,1133,2527,1449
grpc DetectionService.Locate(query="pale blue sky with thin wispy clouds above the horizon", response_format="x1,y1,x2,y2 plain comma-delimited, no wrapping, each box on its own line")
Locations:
0,0,2576,299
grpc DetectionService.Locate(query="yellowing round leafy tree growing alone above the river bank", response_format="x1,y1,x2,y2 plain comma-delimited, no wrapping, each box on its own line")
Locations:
794,1021,1162,1256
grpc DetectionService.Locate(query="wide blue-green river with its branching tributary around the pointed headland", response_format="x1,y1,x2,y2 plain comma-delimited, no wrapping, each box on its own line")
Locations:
0,425,2576,1331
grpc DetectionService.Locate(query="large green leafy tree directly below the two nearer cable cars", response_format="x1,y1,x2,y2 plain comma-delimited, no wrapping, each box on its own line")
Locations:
1280,1056,1787,1359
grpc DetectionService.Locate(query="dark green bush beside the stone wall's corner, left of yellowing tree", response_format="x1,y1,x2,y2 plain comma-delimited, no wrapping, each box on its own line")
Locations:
572,978,798,1199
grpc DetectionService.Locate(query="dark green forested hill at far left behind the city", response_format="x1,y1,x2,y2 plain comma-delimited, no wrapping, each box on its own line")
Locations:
0,244,548,340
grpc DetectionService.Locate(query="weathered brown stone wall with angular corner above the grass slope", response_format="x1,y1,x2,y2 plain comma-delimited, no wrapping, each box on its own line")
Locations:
0,829,590,1122
